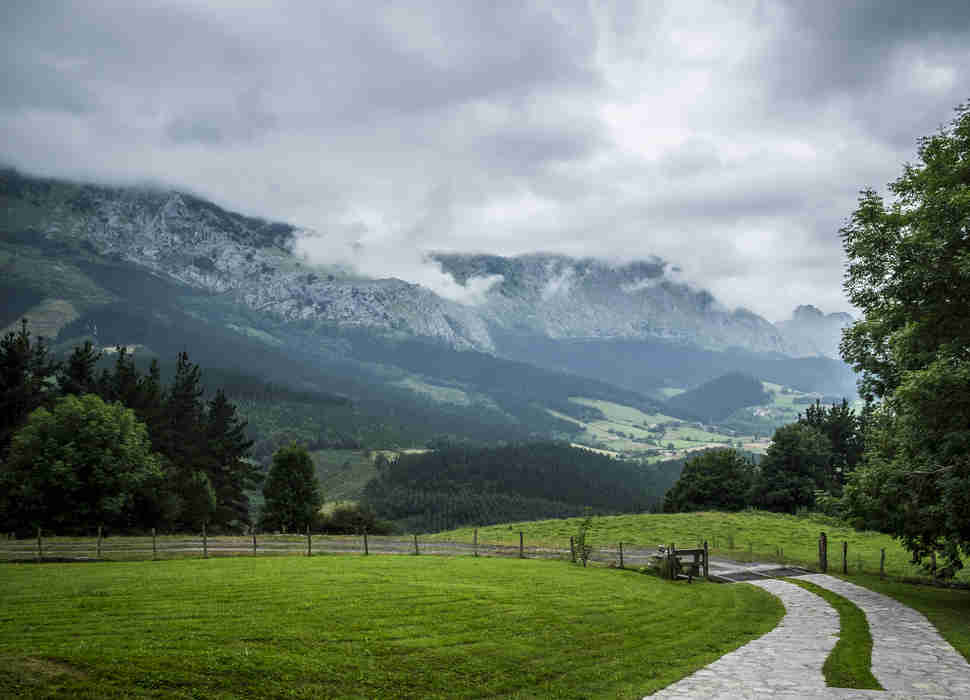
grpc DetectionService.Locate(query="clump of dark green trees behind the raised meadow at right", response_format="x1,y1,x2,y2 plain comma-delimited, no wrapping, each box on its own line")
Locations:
664,399,868,513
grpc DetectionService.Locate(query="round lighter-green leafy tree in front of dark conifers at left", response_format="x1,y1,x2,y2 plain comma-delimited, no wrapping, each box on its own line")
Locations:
0,394,162,532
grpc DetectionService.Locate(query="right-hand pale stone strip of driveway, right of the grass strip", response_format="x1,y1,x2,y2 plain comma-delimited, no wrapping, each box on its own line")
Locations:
799,574,970,698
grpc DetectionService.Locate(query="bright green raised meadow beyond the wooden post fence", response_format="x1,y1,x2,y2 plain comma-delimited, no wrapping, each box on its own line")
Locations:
429,511,970,580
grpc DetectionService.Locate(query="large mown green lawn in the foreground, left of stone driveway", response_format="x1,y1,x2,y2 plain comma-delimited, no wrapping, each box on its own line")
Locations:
0,556,783,698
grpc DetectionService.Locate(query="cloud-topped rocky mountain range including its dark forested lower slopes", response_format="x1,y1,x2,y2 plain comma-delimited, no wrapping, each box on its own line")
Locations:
0,170,853,439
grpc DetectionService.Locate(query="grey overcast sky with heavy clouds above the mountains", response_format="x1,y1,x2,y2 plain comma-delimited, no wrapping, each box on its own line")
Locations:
0,0,970,320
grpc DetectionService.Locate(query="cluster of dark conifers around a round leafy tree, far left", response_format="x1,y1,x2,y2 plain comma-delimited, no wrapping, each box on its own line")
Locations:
0,321,255,532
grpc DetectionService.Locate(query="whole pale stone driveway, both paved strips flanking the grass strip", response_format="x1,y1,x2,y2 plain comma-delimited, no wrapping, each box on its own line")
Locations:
648,574,970,700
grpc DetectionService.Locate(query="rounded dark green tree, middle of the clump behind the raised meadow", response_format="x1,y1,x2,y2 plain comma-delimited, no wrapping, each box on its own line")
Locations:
750,423,832,513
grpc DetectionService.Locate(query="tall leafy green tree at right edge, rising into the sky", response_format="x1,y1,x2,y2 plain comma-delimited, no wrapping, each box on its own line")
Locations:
841,105,970,570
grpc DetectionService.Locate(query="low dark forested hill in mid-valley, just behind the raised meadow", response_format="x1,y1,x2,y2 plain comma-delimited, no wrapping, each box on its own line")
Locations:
364,442,662,531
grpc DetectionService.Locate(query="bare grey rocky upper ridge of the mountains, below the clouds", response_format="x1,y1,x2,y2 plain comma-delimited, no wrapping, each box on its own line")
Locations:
0,170,844,356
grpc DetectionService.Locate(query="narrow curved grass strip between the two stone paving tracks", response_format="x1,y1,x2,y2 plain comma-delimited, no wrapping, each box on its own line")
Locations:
787,578,883,690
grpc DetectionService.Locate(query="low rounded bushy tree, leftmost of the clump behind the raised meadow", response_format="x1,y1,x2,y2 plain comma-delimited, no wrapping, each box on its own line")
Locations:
664,450,754,513
